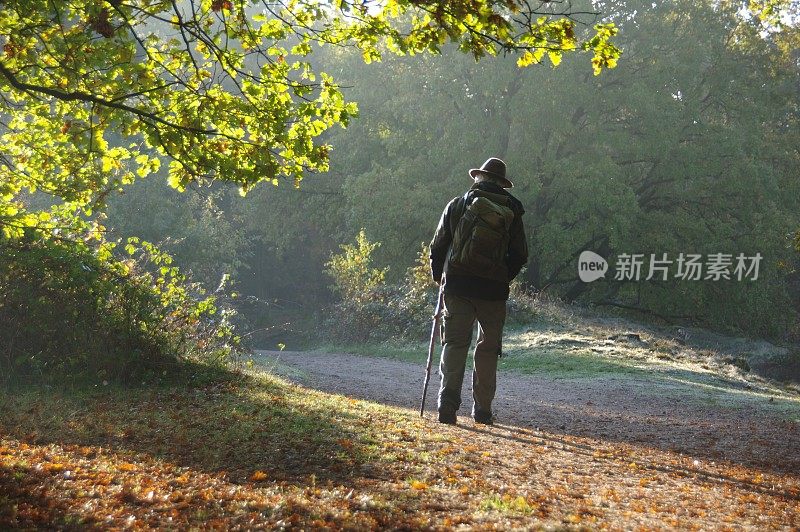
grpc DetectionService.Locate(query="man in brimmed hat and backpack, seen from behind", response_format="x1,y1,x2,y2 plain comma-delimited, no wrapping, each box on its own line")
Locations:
431,157,528,425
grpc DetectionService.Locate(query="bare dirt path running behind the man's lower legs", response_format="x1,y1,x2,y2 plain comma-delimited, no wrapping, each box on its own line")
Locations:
256,351,800,474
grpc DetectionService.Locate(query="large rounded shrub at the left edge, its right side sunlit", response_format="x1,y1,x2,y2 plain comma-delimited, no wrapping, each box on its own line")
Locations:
0,220,240,382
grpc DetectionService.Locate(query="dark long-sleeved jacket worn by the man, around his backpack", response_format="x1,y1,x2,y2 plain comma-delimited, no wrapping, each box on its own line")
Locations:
431,181,528,301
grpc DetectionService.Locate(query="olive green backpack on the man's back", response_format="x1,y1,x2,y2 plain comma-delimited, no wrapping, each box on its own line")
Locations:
447,190,514,282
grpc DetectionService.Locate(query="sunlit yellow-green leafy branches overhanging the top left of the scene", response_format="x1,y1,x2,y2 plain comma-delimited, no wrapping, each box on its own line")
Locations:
0,0,620,234
